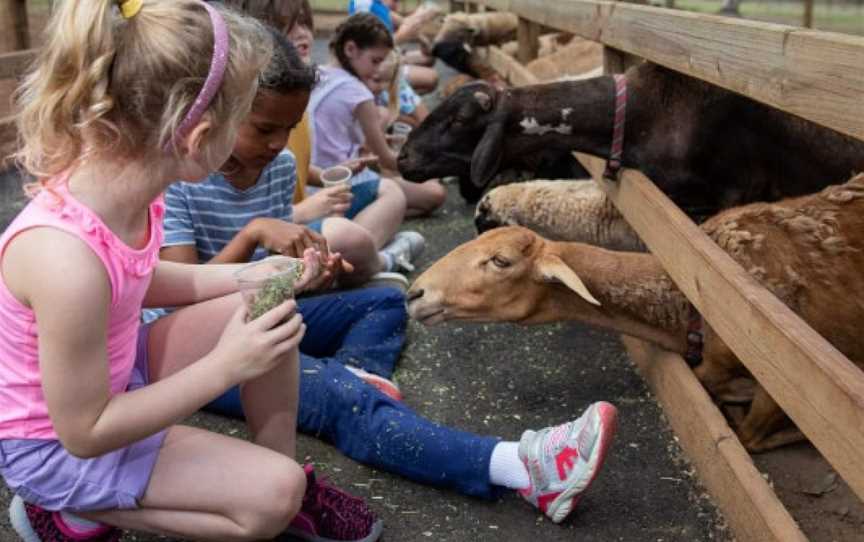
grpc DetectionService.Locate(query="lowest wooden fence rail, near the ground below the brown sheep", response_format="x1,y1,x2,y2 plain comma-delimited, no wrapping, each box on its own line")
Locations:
621,337,807,542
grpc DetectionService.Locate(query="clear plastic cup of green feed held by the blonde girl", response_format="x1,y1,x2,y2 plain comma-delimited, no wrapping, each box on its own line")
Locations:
234,256,305,320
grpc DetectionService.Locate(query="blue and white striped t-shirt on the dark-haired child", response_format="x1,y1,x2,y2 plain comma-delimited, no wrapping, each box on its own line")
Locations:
162,151,297,263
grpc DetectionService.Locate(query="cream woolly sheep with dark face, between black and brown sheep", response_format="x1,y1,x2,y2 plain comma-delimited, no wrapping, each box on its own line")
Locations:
474,179,645,251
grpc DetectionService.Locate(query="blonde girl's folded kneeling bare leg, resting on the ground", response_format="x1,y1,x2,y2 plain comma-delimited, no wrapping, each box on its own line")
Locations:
81,426,306,540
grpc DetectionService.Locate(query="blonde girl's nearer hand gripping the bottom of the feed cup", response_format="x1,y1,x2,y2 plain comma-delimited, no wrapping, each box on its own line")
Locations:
211,299,306,387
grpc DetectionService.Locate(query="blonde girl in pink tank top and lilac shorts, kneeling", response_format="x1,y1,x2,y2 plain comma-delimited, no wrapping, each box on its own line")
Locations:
0,0,354,540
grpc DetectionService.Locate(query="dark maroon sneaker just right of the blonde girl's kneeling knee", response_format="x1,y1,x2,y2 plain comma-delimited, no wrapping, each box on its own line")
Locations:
283,465,384,542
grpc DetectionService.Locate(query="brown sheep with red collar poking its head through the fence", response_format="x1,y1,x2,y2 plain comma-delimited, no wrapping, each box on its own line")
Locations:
408,175,864,452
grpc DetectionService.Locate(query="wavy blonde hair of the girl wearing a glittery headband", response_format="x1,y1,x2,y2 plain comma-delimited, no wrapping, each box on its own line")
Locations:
15,0,271,178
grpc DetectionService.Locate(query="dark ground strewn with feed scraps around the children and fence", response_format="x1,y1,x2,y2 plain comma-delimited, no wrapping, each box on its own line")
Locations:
0,20,864,542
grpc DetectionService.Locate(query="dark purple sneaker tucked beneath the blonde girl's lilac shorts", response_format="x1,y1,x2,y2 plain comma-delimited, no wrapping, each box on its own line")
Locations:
9,495,123,542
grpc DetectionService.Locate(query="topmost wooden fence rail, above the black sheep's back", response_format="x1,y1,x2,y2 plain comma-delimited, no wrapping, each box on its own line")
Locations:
478,0,864,139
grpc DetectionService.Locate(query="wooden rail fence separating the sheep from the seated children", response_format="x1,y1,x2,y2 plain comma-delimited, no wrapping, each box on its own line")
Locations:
451,0,864,542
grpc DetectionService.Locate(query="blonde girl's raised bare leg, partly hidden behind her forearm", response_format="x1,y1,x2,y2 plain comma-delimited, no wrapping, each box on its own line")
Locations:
148,294,299,457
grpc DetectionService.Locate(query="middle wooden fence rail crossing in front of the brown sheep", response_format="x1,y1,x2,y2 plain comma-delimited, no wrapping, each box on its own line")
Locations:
575,153,864,506
